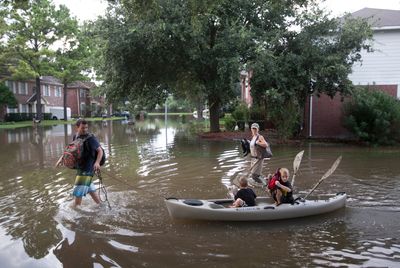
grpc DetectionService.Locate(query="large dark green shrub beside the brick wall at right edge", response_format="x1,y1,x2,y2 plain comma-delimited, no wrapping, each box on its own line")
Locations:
344,88,400,145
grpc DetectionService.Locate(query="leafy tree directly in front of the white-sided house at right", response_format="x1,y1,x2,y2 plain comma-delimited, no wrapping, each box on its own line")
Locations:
249,7,372,137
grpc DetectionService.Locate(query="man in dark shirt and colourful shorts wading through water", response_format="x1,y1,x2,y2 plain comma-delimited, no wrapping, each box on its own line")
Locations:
56,119,103,206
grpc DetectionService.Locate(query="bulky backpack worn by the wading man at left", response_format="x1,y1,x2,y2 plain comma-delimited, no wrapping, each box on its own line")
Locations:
62,134,106,169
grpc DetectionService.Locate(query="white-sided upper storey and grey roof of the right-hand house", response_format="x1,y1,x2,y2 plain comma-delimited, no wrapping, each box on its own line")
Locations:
349,8,400,98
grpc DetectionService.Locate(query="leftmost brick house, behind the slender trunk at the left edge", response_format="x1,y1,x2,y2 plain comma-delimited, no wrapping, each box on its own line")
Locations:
0,76,68,119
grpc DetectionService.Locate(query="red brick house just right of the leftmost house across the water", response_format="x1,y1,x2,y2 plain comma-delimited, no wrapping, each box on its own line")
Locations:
67,81,104,117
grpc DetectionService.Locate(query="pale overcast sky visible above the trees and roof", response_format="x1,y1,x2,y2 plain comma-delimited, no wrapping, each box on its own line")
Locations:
54,0,400,21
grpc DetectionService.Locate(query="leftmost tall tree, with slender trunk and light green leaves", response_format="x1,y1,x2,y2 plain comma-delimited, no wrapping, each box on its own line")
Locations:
5,0,77,119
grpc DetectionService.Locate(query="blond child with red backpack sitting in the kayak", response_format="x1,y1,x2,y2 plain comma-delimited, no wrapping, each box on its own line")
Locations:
268,168,294,205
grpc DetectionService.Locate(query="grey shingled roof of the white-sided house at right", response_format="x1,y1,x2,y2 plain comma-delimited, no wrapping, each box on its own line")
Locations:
351,7,400,30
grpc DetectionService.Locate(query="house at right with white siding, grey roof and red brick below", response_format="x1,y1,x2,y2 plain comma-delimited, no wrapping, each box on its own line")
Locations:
304,8,400,138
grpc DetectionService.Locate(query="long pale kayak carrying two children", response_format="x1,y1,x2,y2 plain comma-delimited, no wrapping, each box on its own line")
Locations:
165,193,347,221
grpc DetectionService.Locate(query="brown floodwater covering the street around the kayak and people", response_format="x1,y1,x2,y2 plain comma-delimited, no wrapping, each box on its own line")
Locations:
0,117,400,267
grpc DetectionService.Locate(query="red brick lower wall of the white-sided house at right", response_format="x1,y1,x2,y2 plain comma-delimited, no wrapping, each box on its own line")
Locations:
302,85,397,138
